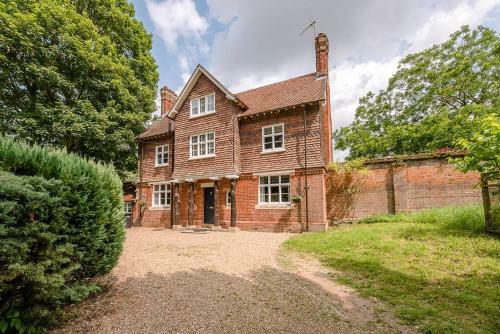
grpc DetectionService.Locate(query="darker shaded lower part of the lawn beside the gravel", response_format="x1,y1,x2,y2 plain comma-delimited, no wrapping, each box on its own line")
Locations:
324,255,500,333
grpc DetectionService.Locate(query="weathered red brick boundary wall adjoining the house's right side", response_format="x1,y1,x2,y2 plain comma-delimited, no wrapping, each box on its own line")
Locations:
326,154,481,221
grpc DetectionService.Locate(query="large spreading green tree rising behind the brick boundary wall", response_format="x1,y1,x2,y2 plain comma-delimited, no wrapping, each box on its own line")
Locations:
334,26,500,158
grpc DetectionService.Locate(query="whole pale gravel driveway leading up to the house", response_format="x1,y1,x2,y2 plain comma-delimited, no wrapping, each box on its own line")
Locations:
53,228,412,333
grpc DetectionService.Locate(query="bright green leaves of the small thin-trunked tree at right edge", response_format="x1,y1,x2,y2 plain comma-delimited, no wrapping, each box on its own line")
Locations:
454,114,500,180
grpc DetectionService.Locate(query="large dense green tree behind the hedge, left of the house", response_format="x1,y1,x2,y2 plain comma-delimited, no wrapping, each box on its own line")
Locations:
0,0,158,173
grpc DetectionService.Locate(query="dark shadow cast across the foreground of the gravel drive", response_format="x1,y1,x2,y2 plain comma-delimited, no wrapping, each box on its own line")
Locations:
53,268,372,333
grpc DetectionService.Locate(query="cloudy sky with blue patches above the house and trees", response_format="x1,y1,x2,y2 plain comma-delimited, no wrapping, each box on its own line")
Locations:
131,0,500,159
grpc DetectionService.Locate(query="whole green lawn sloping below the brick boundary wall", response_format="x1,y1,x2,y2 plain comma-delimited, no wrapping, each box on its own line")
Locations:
285,206,500,333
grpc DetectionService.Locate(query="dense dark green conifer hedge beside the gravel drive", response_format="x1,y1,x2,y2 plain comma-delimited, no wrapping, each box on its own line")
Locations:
0,137,124,332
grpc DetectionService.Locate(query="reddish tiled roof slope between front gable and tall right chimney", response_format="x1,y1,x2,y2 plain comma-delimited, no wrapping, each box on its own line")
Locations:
236,73,327,116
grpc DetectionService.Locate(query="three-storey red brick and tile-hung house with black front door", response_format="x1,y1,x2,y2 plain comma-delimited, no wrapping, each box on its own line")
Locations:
132,34,332,231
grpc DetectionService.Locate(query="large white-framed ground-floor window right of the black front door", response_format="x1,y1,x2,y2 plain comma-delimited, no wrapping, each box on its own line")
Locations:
259,175,290,204
